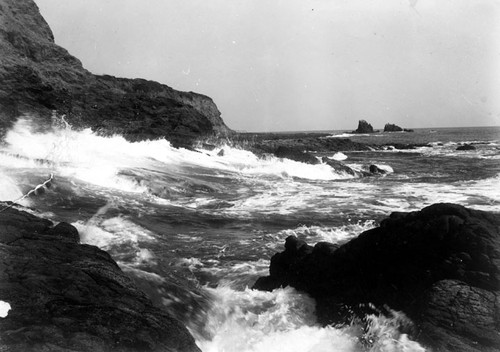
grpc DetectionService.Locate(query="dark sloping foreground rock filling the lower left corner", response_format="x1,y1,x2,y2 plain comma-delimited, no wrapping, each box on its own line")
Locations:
0,204,199,352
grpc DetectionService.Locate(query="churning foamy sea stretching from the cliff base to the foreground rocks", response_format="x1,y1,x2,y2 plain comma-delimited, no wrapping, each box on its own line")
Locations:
0,118,500,352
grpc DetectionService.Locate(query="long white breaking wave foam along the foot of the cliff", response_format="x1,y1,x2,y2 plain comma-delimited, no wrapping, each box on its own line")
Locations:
0,118,352,201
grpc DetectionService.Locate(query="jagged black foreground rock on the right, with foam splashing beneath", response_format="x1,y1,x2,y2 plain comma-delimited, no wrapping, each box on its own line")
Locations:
254,204,500,352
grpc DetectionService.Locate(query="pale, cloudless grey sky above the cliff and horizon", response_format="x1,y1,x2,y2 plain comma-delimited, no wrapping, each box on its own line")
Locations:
35,0,500,132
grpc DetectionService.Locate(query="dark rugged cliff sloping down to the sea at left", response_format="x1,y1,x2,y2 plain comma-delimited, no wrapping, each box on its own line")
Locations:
0,0,231,145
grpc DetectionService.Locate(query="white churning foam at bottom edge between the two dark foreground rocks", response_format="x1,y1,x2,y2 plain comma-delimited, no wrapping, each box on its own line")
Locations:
190,286,424,352
